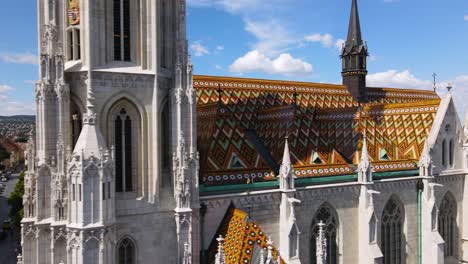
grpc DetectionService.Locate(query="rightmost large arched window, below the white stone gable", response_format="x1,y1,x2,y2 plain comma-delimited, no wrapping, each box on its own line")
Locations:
438,194,458,257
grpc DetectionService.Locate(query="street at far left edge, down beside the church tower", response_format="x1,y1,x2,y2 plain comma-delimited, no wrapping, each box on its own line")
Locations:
0,173,19,264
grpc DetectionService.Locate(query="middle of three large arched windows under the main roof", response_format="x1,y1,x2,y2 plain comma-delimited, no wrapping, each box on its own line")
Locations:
380,197,404,264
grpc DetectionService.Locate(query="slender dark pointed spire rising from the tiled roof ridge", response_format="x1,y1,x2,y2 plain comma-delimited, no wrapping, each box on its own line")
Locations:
341,0,369,103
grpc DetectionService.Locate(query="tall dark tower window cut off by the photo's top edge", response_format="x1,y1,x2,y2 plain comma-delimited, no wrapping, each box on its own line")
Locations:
113,0,131,61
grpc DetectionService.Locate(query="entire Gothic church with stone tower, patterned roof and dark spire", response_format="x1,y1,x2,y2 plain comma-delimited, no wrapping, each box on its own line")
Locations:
22,0,468,264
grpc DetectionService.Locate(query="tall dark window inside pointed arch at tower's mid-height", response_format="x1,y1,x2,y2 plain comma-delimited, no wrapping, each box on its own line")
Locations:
114,108,133,192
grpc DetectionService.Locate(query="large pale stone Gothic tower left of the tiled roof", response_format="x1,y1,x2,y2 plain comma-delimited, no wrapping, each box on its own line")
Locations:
22,0,200,264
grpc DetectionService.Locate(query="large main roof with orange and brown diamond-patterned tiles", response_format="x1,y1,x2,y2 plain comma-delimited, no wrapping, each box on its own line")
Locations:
194,76,440,186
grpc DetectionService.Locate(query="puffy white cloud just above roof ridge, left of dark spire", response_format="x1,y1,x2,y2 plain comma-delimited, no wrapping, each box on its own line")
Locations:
229,50,313,76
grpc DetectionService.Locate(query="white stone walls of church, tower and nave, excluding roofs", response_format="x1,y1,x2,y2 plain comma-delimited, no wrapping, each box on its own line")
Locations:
22,0,468,264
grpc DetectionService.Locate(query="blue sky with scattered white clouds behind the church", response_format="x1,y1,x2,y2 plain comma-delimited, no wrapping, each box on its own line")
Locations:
0,0,468,115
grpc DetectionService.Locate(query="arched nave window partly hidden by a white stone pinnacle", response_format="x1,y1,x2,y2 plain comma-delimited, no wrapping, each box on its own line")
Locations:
310,204,338,264
